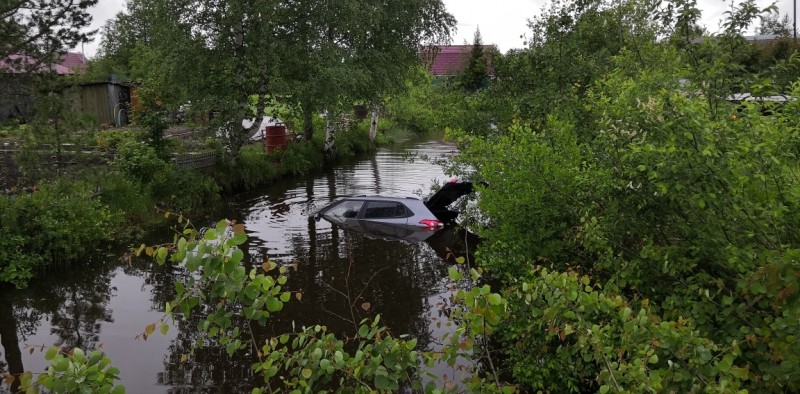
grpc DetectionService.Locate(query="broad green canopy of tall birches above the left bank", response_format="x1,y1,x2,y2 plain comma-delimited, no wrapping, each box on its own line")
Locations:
94,0,455,158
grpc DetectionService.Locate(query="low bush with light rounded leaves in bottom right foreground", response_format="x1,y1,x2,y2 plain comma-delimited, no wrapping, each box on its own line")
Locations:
502,267,764,392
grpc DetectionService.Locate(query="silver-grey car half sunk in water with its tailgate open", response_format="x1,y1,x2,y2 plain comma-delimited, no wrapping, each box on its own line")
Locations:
314,181,473,234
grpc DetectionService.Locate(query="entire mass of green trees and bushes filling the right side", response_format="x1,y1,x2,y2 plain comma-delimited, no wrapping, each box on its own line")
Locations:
440,2,800,392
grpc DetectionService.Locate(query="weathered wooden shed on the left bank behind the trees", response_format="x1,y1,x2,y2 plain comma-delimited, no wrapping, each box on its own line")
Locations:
78,82,131,126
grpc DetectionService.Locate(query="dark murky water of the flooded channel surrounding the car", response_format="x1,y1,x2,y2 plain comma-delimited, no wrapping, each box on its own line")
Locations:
0,137,472,393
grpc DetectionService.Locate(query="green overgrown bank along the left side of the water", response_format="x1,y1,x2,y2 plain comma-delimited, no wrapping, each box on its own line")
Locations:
0,115,405,287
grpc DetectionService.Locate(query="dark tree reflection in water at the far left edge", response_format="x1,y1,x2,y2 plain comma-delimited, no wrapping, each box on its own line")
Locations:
0,260,114,392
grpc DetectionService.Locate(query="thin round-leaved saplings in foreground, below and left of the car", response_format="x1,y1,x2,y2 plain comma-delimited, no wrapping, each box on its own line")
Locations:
147,220,428,392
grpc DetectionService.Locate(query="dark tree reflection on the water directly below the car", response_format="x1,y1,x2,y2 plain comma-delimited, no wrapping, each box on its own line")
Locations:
271,223,454,347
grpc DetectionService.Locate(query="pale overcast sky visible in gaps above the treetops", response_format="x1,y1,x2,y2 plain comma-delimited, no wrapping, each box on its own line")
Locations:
79,0,793,57
